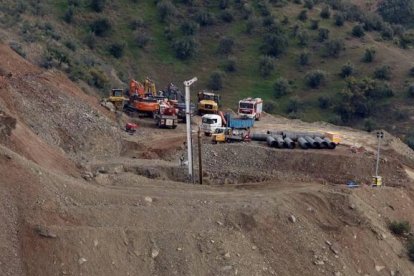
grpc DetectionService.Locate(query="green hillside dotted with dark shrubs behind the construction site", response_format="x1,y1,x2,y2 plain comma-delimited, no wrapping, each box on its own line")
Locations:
0,0,414,141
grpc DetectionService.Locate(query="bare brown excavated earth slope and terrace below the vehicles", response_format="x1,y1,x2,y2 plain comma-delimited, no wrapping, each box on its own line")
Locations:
0,44,414,275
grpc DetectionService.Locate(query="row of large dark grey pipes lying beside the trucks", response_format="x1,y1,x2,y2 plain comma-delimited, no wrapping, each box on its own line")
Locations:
251,131,336,149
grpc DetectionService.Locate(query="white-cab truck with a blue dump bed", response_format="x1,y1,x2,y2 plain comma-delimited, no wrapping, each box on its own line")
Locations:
201,112,254,136
